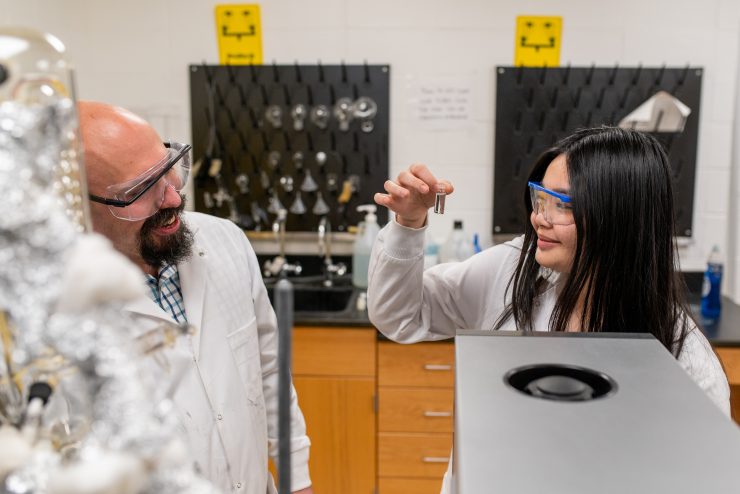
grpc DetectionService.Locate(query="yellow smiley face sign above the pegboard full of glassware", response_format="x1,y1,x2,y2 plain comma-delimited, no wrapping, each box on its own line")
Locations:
216,4,262,65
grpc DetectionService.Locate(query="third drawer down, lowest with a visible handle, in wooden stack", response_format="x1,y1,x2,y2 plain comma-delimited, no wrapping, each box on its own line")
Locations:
378,432,452,479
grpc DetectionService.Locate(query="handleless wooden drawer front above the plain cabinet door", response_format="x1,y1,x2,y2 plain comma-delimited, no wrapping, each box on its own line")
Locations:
291,328,377,377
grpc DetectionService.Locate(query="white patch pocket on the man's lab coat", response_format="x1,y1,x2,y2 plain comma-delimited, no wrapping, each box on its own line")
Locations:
226,318,263,405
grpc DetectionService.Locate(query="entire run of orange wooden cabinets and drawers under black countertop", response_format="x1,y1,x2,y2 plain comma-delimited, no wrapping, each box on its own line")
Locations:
293,327,740,494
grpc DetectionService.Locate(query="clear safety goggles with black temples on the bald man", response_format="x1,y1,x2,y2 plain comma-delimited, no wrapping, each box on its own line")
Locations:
90,142,191,221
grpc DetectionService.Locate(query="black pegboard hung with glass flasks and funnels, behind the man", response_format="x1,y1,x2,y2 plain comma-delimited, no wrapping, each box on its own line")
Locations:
190,64,390,231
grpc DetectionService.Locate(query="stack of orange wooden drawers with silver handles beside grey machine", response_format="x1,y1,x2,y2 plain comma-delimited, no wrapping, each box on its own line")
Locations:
378,342,454,494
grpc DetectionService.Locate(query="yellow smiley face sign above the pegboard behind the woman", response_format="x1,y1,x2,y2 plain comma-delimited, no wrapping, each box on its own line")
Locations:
514,16,563,67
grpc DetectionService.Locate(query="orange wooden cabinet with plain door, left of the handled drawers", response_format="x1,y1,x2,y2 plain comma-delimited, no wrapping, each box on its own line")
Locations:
292,328,377,494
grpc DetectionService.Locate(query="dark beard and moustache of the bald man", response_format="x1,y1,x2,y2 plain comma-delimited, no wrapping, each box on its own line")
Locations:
139,194,193,269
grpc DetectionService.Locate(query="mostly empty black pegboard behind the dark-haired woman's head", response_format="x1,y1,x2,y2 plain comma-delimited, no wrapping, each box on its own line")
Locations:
493,66,703,237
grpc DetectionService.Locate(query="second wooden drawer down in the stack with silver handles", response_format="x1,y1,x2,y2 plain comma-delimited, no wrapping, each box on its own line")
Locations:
378,387,455,432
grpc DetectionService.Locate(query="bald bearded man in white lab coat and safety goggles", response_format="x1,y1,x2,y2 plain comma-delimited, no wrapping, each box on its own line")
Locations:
78,102,312,494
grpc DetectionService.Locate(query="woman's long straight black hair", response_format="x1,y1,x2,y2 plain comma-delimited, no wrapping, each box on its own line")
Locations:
496,127,690,356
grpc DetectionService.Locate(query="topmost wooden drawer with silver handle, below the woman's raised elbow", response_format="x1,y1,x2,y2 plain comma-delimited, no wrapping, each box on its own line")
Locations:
378,342,455,388
